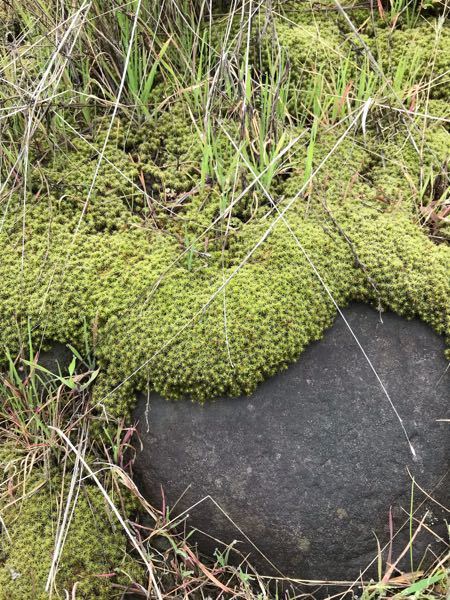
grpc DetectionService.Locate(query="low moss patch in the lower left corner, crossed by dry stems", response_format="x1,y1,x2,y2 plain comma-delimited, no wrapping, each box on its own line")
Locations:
0,447,143,600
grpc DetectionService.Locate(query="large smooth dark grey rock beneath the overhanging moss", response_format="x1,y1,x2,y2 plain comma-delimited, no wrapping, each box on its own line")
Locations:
134,305,449,580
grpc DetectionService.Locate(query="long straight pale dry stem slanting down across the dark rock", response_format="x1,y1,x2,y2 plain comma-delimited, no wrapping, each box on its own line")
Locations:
221,104,417,460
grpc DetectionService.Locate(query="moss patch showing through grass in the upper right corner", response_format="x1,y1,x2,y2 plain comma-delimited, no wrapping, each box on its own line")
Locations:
277,9,450,105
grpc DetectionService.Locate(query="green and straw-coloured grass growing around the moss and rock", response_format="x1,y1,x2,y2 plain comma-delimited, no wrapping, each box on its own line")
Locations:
0,0,450,600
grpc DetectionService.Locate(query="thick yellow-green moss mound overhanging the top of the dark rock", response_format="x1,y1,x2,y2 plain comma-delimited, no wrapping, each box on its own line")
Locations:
0,117,450,416
